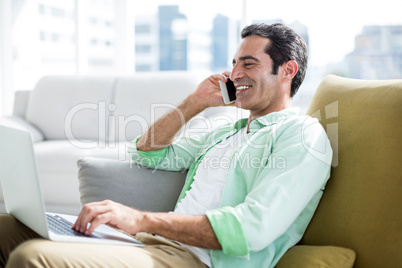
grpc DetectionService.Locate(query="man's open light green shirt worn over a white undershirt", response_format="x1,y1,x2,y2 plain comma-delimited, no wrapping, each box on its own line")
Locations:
129,109,332,268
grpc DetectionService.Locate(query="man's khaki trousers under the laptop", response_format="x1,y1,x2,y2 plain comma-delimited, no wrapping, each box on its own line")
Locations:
0,215,206,268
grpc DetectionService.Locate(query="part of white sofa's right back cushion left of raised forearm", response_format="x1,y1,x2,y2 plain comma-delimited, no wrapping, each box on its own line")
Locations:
110,71,200,141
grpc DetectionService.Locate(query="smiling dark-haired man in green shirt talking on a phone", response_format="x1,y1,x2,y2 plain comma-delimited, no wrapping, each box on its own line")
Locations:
0,24,332,267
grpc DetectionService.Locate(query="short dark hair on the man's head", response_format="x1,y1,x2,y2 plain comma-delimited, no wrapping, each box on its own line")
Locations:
241,23,308,97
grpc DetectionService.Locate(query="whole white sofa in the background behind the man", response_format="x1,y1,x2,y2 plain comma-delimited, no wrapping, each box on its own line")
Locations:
0,71,248,214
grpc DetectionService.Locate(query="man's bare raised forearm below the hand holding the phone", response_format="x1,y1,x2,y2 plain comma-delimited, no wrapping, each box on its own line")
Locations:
137,95,206,151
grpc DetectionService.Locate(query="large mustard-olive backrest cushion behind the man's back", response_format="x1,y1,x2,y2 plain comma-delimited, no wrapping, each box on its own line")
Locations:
302,75,402,267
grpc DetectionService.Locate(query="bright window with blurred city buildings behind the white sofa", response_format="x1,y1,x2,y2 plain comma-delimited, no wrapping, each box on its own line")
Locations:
0,0,402,114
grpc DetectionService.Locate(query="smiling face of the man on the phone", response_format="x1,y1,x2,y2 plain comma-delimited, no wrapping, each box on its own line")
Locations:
230,35,280,116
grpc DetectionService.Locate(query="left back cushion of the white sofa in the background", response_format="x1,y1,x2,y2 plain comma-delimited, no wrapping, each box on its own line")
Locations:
26,76,115,140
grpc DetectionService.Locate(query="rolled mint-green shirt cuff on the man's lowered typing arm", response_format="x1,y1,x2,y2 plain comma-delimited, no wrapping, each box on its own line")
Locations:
206,207,250,256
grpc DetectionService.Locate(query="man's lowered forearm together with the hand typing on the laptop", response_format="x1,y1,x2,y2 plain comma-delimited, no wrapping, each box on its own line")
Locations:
72,200,221,249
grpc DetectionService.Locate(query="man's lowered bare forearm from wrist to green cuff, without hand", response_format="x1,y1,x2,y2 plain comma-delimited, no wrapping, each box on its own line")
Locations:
142,212,222,249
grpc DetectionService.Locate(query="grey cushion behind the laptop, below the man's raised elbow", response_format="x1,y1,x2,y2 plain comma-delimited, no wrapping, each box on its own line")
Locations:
77,157,186,212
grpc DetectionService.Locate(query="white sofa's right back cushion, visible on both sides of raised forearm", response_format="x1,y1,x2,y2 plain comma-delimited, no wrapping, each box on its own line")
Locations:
110,71,249,141
